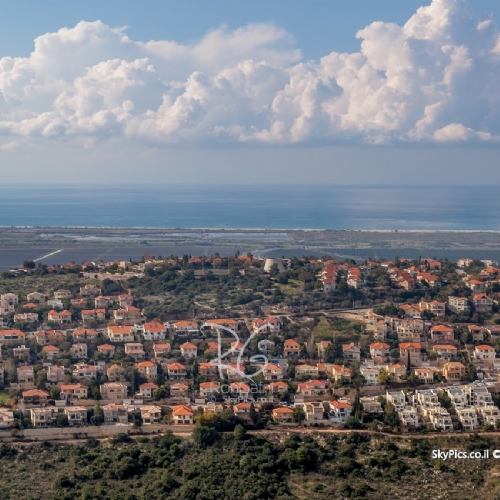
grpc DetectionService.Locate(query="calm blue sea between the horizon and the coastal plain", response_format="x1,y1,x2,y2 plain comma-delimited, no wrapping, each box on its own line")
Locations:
0,184,500,231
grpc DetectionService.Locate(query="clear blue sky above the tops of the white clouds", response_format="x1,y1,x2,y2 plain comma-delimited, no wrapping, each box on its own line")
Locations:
0,0,500,59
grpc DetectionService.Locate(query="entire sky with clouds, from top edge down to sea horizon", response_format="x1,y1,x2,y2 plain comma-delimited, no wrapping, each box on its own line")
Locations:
0,0,500,185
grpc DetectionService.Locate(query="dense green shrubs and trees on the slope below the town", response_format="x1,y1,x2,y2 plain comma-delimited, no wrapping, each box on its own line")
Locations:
0,425,500,500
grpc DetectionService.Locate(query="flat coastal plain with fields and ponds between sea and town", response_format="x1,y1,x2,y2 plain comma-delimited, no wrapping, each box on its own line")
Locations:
0,227,500,270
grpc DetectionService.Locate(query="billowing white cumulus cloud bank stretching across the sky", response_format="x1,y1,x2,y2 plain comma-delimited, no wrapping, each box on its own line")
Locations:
0,0,500,149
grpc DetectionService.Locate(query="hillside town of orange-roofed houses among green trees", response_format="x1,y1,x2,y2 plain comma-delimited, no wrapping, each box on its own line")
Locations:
0,254,500,439
